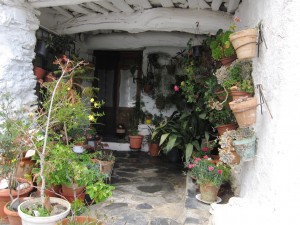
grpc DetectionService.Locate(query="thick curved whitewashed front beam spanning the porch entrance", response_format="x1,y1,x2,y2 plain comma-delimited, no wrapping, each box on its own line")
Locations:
56,8,232,34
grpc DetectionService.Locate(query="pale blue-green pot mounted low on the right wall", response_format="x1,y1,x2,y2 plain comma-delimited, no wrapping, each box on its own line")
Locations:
232,136,256,161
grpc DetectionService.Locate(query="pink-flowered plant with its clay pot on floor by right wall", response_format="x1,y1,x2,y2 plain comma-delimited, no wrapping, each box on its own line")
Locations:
189,156,230,203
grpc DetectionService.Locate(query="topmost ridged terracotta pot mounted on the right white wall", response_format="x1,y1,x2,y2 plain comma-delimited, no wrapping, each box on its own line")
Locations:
229,28,257,59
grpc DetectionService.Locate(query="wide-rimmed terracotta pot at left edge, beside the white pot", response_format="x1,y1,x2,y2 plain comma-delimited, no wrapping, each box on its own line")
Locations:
0,178,33,223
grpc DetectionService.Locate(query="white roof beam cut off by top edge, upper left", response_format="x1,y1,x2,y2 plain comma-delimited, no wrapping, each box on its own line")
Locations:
28,0,102,8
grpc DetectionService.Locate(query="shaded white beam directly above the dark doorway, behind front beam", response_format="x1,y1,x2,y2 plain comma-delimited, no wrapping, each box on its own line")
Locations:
86,32,196,50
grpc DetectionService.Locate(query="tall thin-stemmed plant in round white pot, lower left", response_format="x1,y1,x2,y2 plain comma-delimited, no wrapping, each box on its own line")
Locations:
18,56,108,224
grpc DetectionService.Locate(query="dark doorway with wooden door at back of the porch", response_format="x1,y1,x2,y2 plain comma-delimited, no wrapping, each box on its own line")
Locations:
93,51,143,141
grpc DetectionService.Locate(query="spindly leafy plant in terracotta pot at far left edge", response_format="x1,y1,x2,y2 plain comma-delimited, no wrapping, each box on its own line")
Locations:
0,93,33,222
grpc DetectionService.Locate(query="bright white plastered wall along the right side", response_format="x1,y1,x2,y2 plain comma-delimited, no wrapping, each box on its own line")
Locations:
212,0,300,225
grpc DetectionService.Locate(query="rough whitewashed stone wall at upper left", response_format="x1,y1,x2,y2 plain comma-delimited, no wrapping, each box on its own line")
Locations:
0,1,39,110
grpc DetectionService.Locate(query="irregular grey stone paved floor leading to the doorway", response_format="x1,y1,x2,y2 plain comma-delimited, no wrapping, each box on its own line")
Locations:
89,151,186,225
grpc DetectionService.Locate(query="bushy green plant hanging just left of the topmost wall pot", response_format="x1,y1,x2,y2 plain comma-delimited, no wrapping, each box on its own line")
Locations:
209,29,236,66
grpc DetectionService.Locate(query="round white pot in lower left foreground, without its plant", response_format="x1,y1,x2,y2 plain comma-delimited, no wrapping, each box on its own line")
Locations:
18,197,71,225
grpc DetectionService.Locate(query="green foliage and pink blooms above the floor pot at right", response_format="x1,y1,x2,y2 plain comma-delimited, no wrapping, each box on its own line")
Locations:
188,155,230,187
